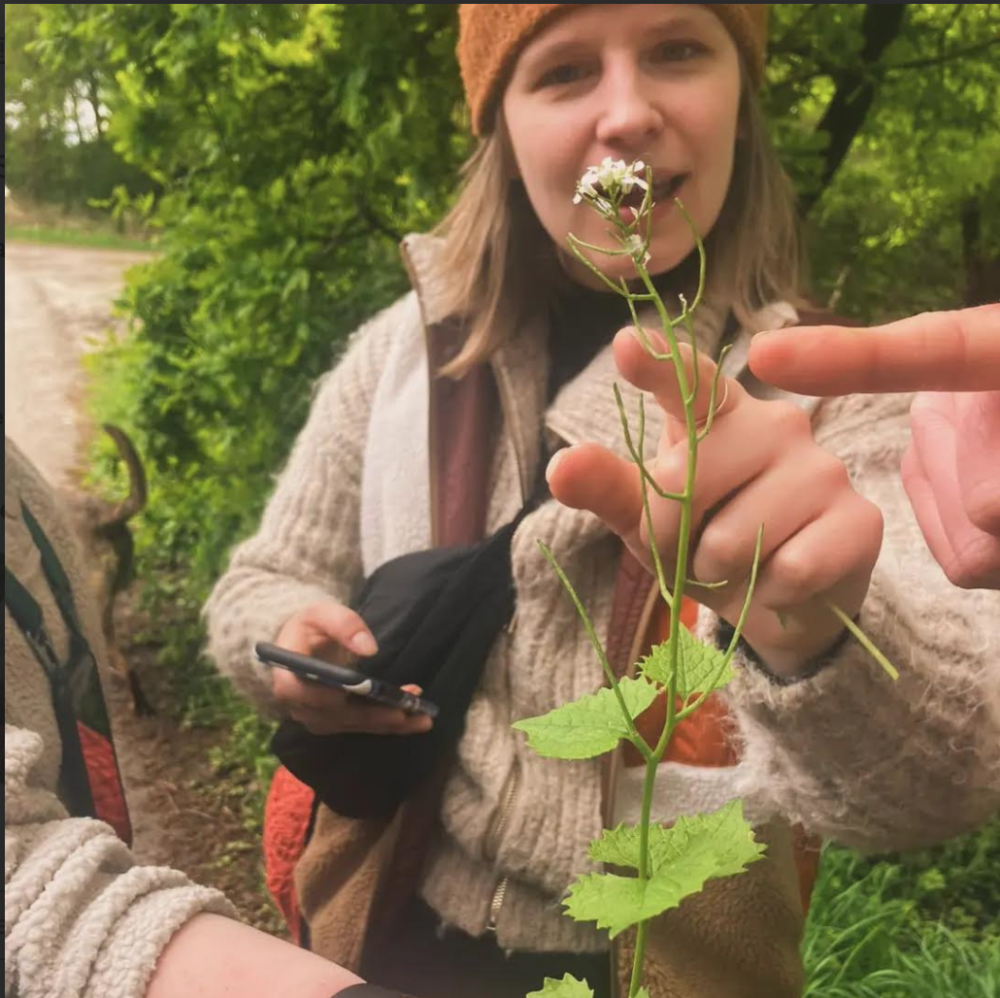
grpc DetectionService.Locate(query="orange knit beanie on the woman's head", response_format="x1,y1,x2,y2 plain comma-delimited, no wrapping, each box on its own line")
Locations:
458,3,769,135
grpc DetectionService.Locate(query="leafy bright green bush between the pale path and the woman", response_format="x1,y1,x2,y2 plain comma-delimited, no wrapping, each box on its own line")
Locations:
31,4,465,724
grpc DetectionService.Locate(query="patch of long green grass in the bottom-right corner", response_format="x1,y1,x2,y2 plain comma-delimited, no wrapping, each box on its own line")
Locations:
803,822,1000,998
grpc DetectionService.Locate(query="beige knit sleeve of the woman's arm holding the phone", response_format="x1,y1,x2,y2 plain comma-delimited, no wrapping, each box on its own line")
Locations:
205,294,408,714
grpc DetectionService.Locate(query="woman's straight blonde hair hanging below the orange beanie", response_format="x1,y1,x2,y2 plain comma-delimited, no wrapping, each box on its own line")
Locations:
435,71,803,378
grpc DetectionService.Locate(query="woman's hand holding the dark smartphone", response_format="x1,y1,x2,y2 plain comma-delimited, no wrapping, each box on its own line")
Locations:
271,601,433,735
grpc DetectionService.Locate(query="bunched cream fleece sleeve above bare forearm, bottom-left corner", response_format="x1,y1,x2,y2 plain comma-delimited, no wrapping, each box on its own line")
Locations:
4,724,234,998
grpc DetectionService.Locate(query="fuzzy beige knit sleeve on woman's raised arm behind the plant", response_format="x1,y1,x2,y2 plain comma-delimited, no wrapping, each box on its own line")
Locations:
712,396,1000,851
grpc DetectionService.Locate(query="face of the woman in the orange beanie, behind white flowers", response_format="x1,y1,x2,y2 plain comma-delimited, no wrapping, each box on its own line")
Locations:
503,4,741,280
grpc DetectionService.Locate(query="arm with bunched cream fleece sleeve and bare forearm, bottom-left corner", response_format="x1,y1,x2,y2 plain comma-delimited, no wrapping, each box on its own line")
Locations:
4,725,361,998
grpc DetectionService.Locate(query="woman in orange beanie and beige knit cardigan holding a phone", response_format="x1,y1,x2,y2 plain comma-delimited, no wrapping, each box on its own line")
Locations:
207,4,1000,998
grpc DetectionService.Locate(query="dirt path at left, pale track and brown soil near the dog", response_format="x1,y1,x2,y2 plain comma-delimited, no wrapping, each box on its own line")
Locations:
4,243,280,931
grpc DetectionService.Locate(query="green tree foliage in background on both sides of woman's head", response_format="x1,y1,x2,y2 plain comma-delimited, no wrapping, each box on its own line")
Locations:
5,4,1000,596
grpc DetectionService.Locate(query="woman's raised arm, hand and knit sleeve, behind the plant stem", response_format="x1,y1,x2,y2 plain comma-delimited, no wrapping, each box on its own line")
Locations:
549,334,1000,849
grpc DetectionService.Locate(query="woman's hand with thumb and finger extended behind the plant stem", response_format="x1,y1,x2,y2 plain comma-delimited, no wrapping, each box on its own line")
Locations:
548,330,882,675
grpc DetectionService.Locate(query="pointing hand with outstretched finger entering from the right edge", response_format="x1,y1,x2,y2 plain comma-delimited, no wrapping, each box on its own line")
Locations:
749,304,1000,589
